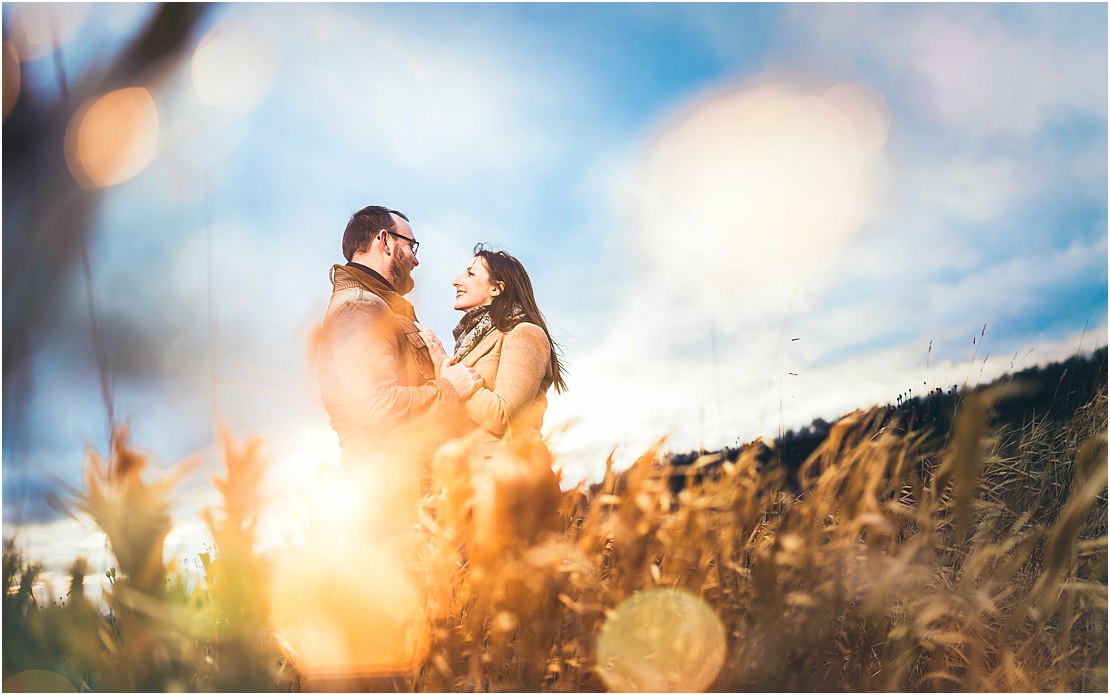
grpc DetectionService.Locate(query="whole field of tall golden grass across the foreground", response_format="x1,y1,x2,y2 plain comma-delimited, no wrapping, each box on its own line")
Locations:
3,368,1107,693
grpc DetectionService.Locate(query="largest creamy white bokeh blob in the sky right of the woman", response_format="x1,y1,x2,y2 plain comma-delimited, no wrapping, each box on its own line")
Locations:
636,82,890,292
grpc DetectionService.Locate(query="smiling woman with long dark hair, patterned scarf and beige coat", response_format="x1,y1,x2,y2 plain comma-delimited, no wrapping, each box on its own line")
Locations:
422,244,566,457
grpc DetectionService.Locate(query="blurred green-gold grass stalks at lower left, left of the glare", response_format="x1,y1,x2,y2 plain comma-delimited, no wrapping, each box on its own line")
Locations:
3,429,295,692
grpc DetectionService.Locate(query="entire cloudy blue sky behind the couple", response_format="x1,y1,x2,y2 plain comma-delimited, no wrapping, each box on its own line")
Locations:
3,3,1107,581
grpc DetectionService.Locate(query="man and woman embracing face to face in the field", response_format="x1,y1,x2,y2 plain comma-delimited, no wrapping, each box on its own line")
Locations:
317,205,566,539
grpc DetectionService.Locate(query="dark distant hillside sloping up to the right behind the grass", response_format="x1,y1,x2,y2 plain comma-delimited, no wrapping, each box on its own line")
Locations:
668,348,1107,490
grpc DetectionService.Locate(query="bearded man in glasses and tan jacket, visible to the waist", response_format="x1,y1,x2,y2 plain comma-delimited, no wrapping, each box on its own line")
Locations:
317,205,481,469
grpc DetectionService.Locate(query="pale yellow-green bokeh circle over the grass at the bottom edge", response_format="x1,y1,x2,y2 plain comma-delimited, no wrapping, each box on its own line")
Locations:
597,588,726,693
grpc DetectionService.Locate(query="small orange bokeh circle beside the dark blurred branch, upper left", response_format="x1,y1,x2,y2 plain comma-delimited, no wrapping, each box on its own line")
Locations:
65,87,161,188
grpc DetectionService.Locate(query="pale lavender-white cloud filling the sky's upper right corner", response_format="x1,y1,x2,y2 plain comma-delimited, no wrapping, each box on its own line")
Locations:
790,3,1107,138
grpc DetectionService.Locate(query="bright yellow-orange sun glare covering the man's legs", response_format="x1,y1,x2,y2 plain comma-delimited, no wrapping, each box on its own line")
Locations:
272,457,427,686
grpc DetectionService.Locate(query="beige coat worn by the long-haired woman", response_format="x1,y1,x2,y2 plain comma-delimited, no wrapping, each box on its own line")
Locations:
462,323,552,451
